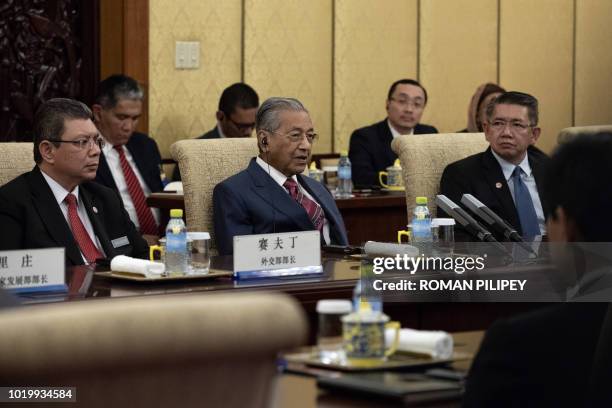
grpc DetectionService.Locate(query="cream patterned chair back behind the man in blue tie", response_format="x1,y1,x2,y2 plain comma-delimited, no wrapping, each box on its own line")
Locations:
391,133,489,220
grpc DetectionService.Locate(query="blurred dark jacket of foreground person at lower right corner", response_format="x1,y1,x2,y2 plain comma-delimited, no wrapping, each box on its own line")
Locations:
464,303,608,407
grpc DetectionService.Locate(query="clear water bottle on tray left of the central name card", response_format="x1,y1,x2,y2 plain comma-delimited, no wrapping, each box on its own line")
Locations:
165,209,189,276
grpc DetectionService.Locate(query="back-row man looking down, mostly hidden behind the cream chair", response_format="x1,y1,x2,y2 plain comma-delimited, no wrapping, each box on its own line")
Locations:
172,82,259,181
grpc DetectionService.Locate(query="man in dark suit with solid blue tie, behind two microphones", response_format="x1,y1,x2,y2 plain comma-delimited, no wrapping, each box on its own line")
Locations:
438,92,548,240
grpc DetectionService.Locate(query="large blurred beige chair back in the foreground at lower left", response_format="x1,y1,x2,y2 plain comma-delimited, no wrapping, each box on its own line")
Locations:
0,293,307,407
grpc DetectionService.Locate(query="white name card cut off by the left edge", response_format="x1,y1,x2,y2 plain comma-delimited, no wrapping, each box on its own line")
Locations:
0,248,66,292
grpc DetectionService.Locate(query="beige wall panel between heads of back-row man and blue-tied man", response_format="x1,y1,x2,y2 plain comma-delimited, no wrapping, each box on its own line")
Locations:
419,0,497,132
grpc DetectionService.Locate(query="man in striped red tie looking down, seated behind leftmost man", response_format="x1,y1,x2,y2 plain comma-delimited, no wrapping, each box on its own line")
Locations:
93,75,163,235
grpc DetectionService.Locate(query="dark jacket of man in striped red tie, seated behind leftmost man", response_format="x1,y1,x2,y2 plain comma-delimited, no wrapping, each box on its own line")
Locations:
96,132,164,193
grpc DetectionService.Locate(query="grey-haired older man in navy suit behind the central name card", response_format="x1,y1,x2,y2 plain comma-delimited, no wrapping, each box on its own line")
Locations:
213,98,348,255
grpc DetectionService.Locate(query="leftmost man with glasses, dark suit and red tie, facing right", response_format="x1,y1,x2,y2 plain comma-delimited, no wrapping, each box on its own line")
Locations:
0,98,149,265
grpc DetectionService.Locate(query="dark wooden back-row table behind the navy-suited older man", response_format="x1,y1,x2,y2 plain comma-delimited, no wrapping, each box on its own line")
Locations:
147,192,408,245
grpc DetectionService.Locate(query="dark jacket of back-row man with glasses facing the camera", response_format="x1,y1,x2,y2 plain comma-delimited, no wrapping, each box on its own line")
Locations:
349,119,438,188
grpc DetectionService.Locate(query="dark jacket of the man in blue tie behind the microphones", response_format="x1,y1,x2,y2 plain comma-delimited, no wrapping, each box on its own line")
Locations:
437,147,548,241
